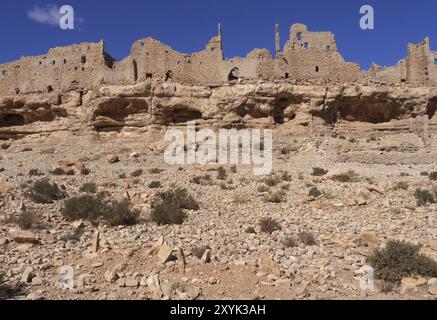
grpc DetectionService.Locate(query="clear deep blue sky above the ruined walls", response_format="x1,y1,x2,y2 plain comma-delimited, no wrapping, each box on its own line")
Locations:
0,0,437,69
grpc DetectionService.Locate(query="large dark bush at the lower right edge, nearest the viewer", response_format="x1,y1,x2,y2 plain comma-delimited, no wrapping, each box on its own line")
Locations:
367,241,437,283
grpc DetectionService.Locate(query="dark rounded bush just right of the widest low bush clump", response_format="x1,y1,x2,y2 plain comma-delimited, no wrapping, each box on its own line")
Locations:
151,188,199,225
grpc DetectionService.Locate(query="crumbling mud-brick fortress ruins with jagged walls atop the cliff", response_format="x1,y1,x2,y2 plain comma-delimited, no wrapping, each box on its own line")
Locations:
0,24,437,96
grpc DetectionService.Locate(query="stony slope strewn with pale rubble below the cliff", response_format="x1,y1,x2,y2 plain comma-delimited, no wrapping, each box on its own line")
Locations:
0,127,437,299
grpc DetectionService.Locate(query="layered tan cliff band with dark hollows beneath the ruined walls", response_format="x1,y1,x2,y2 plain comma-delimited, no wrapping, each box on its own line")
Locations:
0,82,437,137
